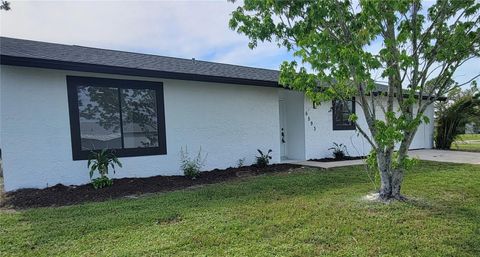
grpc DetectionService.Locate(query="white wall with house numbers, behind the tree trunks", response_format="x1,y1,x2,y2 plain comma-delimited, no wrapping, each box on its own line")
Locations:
304,99,434,160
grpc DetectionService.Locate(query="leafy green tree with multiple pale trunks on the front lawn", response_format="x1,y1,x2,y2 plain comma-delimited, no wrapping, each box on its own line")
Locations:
229,0,480,200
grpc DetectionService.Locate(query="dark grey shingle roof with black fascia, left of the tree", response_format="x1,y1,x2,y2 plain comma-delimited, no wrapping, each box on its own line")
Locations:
0,37,279,87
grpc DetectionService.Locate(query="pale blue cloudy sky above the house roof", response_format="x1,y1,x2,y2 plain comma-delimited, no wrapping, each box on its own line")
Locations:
0,0,480,84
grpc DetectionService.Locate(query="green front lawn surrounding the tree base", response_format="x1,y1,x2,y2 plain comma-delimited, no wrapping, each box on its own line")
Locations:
0,162,480,256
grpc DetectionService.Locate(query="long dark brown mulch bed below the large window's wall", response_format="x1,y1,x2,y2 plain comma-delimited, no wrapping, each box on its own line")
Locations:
0,164,299,209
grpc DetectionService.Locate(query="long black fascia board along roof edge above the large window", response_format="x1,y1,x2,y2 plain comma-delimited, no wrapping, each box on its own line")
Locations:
0,54,281,88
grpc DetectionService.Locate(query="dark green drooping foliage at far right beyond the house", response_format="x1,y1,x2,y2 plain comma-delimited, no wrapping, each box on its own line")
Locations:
435,87,480,150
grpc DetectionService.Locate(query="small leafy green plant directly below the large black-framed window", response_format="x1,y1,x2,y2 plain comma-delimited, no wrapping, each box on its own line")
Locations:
87,149,122,189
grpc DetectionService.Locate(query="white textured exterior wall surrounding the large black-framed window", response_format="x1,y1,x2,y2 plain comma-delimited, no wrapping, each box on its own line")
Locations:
0,66,280,191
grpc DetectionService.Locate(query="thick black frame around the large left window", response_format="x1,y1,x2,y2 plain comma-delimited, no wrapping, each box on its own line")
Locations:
67,76,167,160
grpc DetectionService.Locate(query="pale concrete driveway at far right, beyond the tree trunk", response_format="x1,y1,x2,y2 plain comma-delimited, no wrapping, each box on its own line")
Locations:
408,149,480,164
